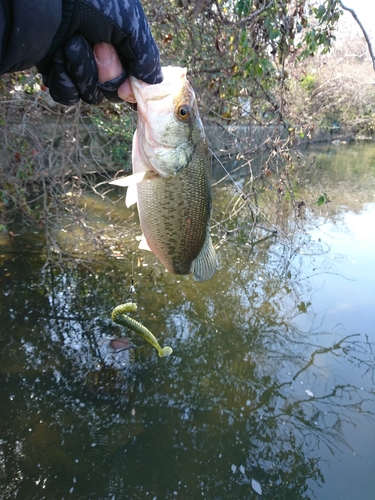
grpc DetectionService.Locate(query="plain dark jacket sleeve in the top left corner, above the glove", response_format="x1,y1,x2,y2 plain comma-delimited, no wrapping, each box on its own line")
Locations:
0,0,71,74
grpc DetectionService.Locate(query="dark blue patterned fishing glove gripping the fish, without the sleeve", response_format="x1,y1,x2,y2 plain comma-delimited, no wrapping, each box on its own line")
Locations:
37,0,163,105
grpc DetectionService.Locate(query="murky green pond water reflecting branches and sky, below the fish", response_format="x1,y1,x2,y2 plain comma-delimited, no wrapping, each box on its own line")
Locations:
0,145,375,500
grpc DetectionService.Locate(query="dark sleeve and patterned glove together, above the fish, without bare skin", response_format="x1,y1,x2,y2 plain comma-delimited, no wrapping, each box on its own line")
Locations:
0,0,163,105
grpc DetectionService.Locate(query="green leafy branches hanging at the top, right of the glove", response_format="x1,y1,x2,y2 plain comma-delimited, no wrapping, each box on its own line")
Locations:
144,0,341,123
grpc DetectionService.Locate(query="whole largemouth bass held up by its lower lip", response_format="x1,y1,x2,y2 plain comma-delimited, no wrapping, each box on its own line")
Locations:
111,66,217,281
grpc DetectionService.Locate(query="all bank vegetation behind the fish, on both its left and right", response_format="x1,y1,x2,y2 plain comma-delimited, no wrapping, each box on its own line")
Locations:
0,0,375,256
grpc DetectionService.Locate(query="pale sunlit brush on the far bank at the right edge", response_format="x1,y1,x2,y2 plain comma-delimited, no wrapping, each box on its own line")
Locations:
288,35,375,135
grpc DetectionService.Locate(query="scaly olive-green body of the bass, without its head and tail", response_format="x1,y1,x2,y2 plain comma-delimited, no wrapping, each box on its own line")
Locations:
137,150,211,274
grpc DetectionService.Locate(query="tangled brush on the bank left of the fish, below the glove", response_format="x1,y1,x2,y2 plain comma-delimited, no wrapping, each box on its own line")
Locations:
0,72,135,258
